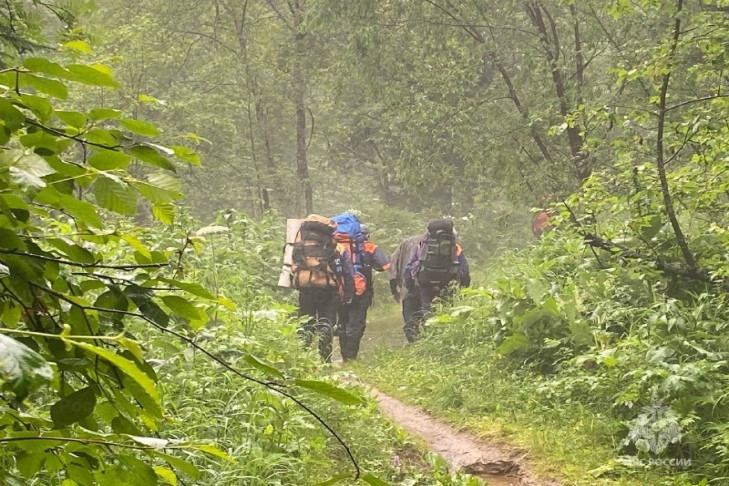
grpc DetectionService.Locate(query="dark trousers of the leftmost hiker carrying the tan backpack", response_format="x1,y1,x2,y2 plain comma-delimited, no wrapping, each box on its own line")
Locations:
299,288,339,362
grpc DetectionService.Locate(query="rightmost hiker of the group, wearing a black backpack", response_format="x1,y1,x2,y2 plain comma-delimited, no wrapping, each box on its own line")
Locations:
403,219,471,336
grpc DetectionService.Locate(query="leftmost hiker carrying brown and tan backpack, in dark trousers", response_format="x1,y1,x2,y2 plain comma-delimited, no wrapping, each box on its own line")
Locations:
291,214,354,362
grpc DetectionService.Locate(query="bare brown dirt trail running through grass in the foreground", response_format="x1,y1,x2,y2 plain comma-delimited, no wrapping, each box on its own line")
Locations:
347,379,559,486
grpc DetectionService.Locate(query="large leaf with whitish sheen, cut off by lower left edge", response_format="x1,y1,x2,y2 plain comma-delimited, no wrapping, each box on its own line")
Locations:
0,334,53,400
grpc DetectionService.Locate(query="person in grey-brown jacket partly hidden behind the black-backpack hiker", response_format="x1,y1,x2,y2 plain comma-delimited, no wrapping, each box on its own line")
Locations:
389,235,423,343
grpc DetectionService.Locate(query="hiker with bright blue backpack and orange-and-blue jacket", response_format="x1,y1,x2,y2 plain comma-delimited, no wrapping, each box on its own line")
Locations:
333,213,390,361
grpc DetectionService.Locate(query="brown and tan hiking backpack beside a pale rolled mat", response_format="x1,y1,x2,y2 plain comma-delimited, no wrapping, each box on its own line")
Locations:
291,214,342,289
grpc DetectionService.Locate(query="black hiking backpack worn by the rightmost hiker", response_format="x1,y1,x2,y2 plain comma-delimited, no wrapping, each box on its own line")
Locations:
417,219,458,287
